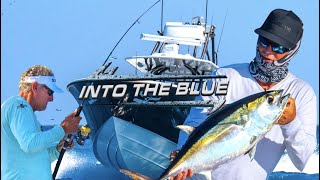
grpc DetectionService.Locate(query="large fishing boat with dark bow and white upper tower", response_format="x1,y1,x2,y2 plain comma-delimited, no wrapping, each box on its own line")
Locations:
67,4,224,178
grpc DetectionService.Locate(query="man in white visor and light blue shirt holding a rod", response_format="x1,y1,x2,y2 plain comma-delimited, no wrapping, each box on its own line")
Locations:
1,65,82,180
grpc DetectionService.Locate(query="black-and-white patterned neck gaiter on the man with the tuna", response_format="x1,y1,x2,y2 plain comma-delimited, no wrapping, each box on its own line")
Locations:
249,40,301,84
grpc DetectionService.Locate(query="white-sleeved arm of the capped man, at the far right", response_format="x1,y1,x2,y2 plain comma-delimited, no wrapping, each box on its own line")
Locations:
280,89,317,171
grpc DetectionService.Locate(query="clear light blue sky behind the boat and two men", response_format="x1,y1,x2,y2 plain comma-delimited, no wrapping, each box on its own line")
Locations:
1,0,319,125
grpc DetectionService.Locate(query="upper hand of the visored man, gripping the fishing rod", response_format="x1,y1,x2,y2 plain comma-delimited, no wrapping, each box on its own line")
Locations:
61,111,82,134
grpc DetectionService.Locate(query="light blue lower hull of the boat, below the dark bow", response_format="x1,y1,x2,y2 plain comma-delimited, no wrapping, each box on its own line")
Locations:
93,116,176,178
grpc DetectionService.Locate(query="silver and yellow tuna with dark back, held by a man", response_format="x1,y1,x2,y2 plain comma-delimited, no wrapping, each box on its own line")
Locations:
120,90,290,179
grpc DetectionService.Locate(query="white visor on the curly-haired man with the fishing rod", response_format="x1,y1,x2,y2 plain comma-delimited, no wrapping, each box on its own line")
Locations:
23,76,63,93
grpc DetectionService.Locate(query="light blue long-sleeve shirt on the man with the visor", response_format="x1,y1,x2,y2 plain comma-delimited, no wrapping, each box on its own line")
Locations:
1,96,65,180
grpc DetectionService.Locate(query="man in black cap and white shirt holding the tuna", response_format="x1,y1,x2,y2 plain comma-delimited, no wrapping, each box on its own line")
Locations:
171,9,317,180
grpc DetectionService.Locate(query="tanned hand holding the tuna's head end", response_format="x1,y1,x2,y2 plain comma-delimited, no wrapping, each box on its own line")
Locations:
276,97,296,125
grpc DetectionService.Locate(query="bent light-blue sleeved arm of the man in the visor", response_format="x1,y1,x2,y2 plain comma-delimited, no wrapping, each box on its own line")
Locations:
9,104,65,153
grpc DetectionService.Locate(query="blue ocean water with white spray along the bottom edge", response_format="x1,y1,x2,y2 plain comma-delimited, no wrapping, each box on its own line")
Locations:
51,128,319,180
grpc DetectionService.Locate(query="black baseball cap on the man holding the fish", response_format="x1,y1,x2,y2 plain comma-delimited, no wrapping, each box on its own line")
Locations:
254,9,303,50
